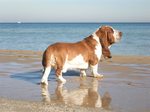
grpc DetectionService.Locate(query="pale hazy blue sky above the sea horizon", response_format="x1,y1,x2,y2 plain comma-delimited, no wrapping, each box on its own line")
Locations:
0,0,150,22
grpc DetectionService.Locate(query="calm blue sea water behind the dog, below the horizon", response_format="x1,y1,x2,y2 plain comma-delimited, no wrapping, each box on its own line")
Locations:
0,23,150,56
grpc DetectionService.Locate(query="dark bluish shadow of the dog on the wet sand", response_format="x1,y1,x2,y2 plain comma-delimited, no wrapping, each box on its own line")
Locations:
10,69,80,84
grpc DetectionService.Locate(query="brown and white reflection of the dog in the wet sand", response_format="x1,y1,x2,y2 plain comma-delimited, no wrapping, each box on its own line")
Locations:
41,78,111,109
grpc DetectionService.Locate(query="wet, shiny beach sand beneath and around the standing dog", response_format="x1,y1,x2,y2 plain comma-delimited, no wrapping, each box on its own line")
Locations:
0,50,150,112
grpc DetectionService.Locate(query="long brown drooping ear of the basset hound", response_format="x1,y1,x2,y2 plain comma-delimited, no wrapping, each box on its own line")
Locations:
100,28,112,58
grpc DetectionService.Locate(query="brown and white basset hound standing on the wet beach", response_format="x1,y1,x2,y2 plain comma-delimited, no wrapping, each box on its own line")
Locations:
41,26,122,85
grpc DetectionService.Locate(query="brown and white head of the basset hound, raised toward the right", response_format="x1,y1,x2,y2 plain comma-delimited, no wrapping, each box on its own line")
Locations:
96,26,122,58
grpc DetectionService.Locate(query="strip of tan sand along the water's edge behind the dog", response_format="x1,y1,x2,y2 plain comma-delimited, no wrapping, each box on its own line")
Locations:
0,50,150,64
